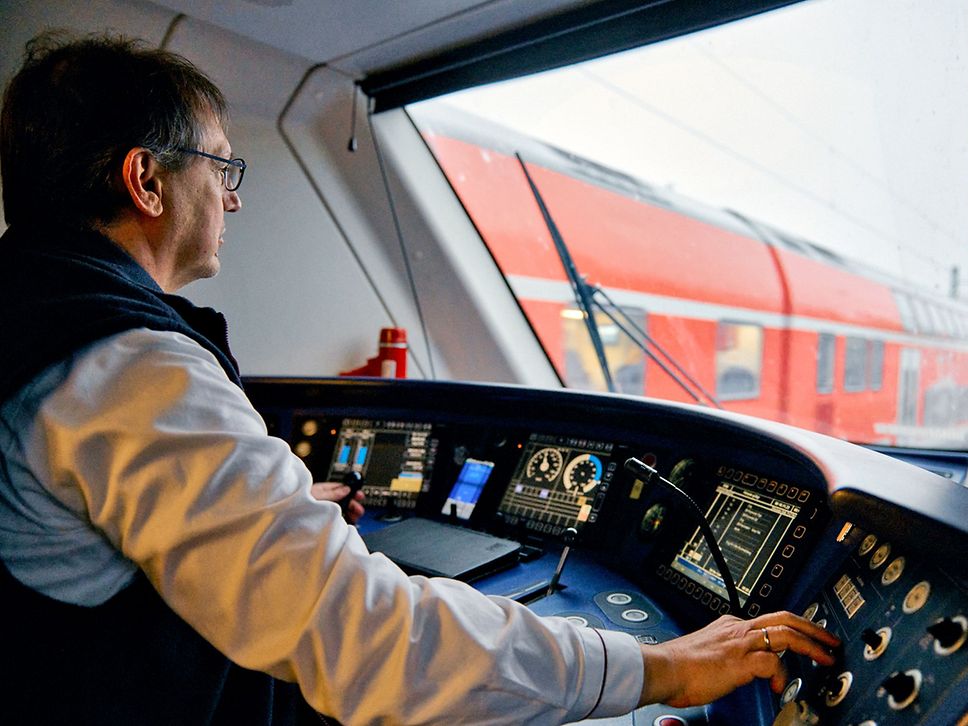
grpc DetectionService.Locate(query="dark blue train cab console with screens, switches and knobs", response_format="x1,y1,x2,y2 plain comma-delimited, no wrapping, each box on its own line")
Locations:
246,378,968,726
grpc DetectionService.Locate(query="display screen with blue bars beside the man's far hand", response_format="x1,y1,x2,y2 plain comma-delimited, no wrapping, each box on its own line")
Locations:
329,419,437,508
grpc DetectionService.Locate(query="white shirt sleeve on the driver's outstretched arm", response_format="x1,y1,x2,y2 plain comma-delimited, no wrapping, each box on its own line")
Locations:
29,330,643,724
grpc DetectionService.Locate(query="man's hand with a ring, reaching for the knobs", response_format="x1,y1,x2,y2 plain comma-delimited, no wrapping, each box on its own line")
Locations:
639,612,840,708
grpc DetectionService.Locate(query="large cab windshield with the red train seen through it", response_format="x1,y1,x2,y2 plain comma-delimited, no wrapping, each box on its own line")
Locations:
408,0,968,449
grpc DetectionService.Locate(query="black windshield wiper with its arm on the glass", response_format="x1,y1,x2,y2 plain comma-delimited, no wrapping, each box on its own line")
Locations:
514,152,723,408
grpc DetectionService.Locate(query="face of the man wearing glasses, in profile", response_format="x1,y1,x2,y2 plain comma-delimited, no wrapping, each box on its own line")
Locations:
165,115,242,291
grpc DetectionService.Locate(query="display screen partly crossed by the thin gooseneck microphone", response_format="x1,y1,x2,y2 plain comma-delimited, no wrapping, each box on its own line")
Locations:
672,482,800,606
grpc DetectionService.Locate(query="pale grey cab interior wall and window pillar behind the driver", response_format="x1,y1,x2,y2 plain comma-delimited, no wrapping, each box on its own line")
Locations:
0,0,558,386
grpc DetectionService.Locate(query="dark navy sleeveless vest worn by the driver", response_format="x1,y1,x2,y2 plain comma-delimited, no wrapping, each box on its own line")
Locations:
0,229,320,726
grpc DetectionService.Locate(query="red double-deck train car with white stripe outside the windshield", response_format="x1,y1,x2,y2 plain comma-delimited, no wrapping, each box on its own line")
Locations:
415,107,968,448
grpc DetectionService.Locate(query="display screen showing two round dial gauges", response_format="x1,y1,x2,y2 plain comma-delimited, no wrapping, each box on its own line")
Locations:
498,434,615,534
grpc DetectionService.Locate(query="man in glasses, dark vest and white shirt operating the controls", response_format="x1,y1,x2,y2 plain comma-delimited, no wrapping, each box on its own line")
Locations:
0,31,836,724
